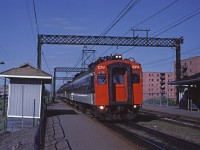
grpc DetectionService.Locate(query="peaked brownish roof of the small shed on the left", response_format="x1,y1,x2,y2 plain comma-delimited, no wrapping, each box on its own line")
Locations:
0,63,52,81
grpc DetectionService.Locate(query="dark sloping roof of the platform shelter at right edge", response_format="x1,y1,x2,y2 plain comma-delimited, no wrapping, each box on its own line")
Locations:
169,73,200,85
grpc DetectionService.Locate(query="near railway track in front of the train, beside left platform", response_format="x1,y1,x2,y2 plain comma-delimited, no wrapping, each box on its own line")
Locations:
105,122,200,150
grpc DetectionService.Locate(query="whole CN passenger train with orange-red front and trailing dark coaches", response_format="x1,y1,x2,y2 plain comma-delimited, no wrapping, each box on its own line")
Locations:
57,54,142,120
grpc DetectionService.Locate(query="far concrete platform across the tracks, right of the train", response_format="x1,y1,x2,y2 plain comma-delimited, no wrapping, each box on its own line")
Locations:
141,105,200,121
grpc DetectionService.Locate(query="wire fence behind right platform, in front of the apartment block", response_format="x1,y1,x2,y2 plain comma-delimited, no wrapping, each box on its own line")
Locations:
143,93,176,106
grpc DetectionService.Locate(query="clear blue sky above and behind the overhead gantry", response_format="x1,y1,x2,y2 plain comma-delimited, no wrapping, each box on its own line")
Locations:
0,0,200,87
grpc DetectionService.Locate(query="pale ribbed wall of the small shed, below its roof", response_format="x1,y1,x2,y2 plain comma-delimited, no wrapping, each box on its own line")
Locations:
8,78,42,118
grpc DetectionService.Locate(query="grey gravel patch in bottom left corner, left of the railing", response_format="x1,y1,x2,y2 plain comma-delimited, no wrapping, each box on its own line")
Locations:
0,127,37,150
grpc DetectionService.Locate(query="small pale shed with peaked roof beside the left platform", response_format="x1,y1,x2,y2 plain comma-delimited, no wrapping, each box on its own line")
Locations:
0,63,52,131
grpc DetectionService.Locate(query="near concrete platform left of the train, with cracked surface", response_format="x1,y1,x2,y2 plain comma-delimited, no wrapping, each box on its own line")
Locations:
45,101,140,150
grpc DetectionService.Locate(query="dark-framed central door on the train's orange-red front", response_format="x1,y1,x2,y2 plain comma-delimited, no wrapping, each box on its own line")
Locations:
108,63,132,104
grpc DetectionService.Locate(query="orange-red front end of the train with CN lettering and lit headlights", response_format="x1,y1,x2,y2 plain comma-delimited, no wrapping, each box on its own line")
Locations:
94,55,142,119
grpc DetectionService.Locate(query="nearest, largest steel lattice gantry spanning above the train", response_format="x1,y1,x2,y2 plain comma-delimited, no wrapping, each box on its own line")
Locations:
37,34,183,102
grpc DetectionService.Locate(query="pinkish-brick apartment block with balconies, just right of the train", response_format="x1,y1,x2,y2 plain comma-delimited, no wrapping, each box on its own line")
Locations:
143,72,176,100
